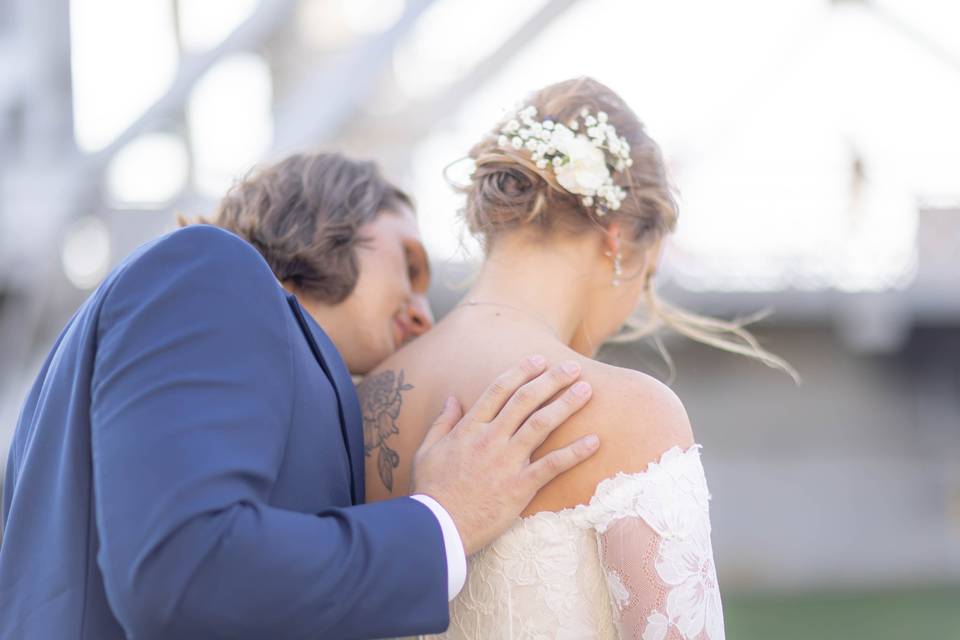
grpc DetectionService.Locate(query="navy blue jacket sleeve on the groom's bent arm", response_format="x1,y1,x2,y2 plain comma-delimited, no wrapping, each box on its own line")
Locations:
91,227,448,638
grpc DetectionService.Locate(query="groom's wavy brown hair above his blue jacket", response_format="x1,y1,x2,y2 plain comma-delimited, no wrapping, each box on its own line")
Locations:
188,153,414,304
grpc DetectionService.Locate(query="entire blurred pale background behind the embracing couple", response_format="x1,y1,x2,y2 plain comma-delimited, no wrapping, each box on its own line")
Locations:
0,0,960,639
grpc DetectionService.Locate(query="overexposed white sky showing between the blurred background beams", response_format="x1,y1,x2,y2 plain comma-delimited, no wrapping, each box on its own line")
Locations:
71,0,960,290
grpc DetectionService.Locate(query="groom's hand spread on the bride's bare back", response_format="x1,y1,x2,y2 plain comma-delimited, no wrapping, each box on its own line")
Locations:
412,356,599,555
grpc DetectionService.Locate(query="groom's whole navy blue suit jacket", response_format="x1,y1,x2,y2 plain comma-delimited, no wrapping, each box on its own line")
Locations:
0,226,448,640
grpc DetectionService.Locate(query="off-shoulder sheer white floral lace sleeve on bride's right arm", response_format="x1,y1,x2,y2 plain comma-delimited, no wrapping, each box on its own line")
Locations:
575,445,724,640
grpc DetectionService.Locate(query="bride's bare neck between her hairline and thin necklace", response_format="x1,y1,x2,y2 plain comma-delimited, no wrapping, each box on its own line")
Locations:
465,238,590,345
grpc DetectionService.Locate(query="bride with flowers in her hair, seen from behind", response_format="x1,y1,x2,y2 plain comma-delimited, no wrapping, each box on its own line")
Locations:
359,78,793,640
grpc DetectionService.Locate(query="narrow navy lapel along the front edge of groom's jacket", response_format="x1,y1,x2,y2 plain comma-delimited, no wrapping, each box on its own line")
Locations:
287,294,366,504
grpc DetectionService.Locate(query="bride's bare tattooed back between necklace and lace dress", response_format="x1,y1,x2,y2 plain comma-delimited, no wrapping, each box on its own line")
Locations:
358,306,693,515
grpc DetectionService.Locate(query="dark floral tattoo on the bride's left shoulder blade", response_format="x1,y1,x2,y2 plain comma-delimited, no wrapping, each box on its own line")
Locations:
357,369,413,491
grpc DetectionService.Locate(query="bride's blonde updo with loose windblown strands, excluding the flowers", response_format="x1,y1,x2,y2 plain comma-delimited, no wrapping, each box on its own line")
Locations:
454,78,800,384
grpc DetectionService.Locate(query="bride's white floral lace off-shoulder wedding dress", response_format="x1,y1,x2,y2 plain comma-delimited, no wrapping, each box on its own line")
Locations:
416,445,724,640
